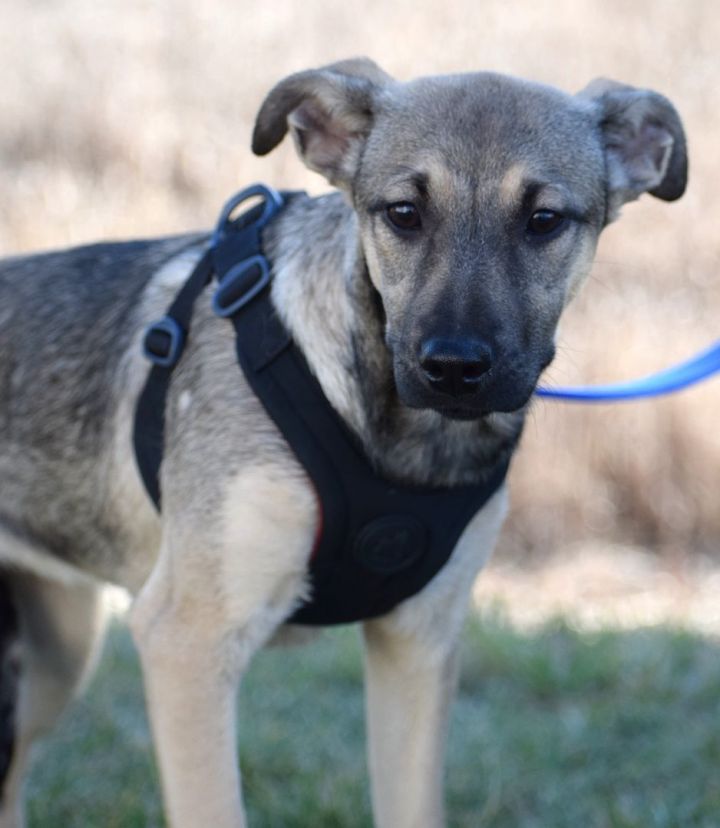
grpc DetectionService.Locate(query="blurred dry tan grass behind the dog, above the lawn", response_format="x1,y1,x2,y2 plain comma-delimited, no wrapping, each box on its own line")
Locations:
0,0,720,557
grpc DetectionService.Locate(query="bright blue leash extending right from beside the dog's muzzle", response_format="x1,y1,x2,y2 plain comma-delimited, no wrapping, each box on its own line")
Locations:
535,339,720,403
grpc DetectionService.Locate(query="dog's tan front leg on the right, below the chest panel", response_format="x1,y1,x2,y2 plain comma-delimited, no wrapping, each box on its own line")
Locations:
364,491,506,828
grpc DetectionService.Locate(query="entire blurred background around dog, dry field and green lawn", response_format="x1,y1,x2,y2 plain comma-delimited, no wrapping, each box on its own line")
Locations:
0,0,720,828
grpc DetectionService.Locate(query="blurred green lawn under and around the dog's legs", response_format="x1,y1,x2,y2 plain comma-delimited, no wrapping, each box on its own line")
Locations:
22,615,720,828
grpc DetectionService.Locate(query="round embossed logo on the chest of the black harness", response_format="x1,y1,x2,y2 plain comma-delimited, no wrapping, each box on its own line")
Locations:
353,515,427,575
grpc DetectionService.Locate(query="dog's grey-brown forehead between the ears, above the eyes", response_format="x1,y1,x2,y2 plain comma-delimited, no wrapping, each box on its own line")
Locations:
364,72,603,201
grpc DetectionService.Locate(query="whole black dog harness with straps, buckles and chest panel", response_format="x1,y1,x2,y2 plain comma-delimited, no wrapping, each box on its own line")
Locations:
134,185,509,624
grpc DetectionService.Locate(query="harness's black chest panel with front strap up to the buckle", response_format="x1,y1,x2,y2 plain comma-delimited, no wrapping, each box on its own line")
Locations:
232,284,510,625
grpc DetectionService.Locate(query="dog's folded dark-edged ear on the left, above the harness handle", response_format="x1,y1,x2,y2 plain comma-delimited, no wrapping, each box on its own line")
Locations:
252,58,393,186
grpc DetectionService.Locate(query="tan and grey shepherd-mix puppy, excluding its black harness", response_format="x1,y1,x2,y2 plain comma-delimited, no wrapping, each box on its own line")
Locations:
0,59,687,828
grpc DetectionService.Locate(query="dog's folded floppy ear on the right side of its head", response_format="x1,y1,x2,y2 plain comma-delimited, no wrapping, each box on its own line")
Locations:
579,78,687,221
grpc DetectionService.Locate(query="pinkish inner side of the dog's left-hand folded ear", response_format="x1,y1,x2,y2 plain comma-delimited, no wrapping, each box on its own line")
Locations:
288,101,352,174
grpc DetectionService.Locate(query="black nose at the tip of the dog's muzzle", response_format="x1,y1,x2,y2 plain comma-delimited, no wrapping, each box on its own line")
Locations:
420,339,492,397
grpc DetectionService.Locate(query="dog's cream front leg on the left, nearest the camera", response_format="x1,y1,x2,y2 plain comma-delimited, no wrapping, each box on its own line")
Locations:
131,467,315,828
